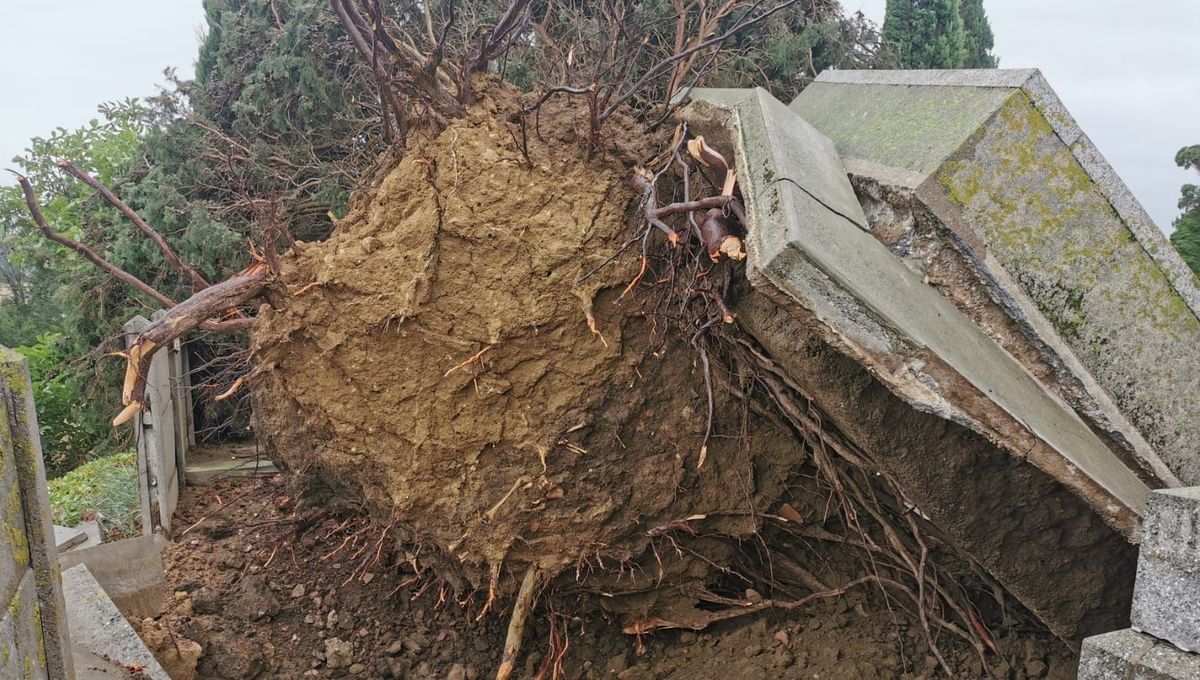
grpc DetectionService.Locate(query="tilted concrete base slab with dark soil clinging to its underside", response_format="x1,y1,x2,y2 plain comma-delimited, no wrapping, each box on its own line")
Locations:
684,90,1147,639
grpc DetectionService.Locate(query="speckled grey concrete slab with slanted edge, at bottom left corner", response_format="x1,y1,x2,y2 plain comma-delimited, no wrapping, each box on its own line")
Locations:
62,565,170,680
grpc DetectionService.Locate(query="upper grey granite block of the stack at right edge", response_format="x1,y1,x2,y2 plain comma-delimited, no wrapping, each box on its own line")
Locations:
1130,487,1200,652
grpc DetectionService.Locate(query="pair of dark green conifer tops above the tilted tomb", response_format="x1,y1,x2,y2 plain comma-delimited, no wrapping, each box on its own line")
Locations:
883,0,996,68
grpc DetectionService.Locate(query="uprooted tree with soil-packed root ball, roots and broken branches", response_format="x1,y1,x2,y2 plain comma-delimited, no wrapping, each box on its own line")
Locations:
11,0,1060,678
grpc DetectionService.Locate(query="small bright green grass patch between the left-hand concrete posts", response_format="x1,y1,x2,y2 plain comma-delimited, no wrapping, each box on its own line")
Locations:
49,450,140,538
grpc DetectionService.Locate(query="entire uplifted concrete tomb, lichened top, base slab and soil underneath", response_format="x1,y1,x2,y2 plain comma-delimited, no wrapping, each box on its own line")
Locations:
684,71,1200,642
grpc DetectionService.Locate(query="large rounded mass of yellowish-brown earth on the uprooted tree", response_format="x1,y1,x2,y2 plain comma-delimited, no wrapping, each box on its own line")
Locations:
253,88,803,609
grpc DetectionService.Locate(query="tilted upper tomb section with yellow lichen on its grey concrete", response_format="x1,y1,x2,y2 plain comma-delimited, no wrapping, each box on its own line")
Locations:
791,71,1200,486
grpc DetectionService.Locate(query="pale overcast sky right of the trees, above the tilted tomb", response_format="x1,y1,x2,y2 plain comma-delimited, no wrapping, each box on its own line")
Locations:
842,0,1200,231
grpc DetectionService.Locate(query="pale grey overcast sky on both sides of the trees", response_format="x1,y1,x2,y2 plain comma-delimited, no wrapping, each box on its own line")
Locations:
0,0,1200,230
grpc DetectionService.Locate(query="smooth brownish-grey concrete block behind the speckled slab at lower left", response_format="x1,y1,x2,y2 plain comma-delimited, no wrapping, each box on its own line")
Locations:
60,534,167,621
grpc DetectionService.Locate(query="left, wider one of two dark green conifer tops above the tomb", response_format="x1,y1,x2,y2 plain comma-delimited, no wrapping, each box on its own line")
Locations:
883,0,964,68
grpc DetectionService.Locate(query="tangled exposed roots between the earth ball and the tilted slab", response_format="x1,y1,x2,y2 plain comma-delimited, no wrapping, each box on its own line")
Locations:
597,126,996,675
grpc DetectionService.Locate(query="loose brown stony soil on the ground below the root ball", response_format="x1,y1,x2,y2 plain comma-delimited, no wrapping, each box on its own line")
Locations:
142,475,1076,680
